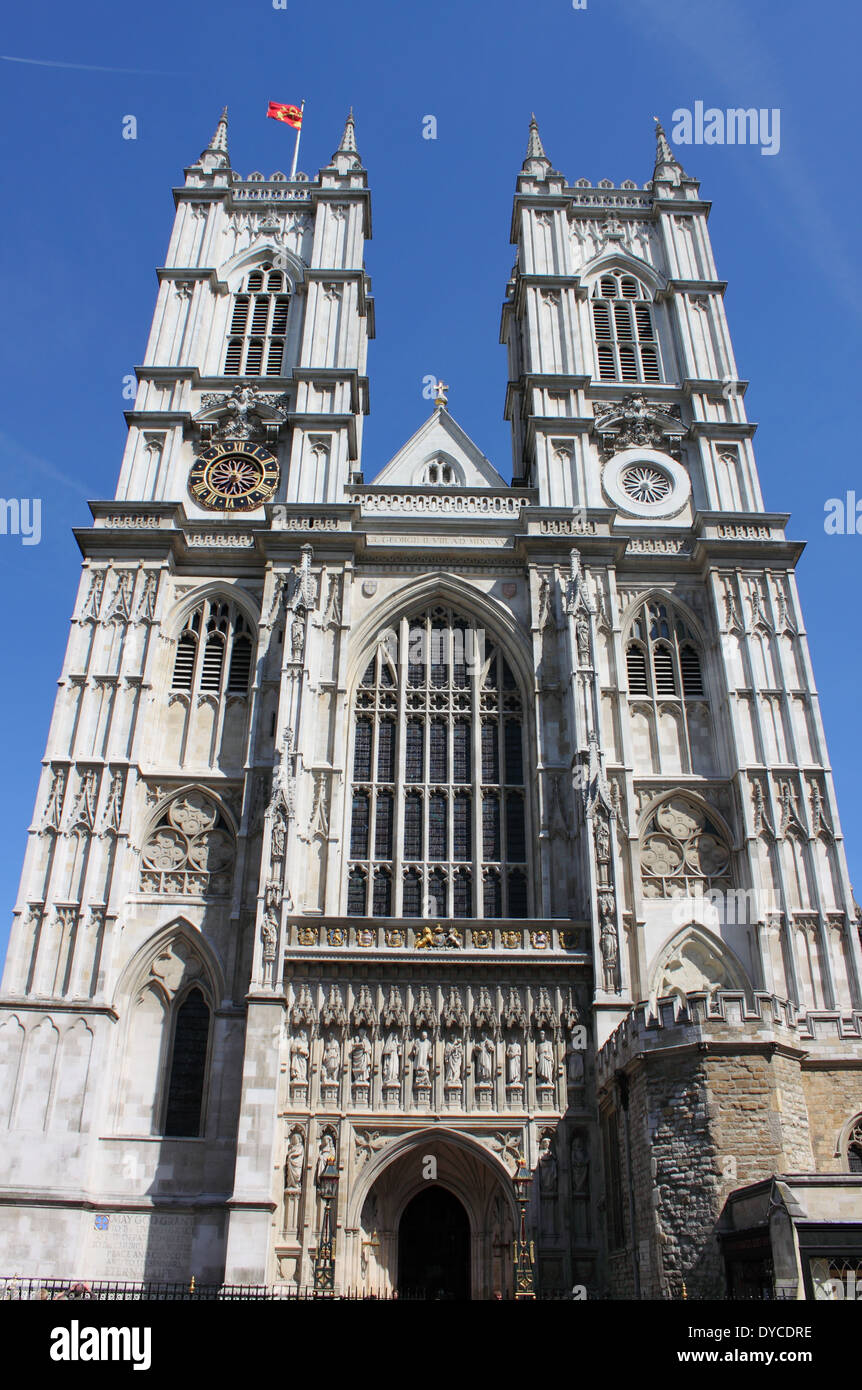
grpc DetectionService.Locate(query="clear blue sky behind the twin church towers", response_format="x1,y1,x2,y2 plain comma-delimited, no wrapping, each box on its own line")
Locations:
0,0,862,967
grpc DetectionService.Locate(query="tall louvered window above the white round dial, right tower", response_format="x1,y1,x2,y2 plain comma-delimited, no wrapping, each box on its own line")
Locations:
592,271,662,381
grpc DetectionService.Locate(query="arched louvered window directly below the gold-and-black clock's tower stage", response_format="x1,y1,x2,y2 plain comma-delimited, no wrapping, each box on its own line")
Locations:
171,599,253,698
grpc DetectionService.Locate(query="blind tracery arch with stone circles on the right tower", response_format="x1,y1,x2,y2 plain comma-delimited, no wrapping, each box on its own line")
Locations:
641,796,733,898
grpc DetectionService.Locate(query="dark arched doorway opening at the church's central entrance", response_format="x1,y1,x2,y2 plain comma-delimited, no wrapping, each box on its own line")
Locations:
398,1183,470,1300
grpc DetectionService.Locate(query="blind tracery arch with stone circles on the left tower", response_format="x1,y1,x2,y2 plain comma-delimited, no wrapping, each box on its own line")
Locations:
140,791,236,898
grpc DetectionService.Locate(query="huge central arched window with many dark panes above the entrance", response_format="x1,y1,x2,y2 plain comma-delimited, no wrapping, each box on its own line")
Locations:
348,607,528,917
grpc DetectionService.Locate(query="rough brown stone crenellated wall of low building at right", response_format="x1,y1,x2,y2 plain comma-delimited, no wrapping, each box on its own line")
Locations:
596,991,862,1298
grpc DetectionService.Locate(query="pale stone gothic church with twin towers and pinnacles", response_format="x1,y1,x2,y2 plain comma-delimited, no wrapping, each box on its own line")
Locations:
0,115,862,1298
